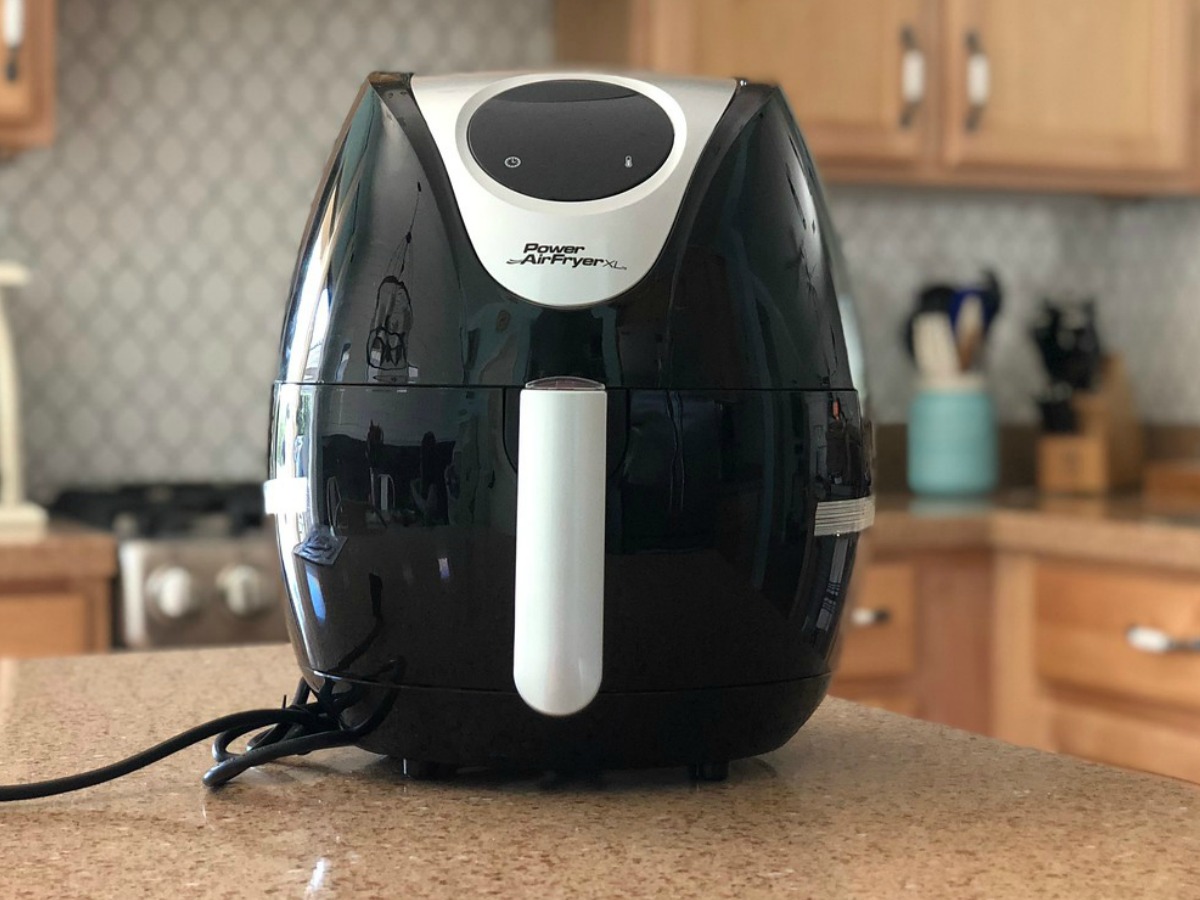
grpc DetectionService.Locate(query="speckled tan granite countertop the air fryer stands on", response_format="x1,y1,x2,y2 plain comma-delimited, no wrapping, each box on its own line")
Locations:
0,647,1200,899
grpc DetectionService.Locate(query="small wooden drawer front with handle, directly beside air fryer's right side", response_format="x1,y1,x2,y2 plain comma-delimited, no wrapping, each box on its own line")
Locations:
838,563,917,678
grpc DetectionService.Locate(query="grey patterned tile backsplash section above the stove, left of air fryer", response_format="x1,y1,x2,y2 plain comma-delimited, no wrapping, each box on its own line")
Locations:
0,0,553,499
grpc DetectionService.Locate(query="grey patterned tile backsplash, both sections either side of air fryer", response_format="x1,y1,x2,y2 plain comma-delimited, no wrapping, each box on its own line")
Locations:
0,0,1200,499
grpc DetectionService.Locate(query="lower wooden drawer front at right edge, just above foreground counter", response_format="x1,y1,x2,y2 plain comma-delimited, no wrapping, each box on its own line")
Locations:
1050,704,1200,781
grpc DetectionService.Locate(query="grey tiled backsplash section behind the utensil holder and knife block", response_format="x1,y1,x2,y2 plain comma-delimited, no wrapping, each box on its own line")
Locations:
829,187,1200,425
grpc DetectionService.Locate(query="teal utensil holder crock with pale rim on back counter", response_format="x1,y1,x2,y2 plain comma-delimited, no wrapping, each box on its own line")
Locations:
908,376,1000,497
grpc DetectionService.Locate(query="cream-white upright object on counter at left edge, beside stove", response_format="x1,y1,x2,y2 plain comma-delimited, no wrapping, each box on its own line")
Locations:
0,263,47,540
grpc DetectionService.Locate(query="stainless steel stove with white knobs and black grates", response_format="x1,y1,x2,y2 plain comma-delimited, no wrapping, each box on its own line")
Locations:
52,484,287,648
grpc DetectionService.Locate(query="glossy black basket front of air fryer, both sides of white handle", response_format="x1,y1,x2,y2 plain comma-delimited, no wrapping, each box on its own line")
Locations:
275,386,868,691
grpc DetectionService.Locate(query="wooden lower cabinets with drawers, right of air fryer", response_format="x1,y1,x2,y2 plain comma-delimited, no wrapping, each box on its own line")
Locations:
830,535,1200,782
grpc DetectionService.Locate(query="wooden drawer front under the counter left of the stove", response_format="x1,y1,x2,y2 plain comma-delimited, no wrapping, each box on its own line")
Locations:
0,592,92,656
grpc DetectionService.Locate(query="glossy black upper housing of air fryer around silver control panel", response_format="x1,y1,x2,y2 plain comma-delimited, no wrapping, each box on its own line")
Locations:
280,77,854,390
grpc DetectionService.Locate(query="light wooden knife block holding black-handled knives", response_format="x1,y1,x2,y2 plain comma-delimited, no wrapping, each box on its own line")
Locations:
1037,355,1145,494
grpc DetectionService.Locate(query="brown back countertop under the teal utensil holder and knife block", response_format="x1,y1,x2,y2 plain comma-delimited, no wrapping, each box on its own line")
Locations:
870,491,1200,572
